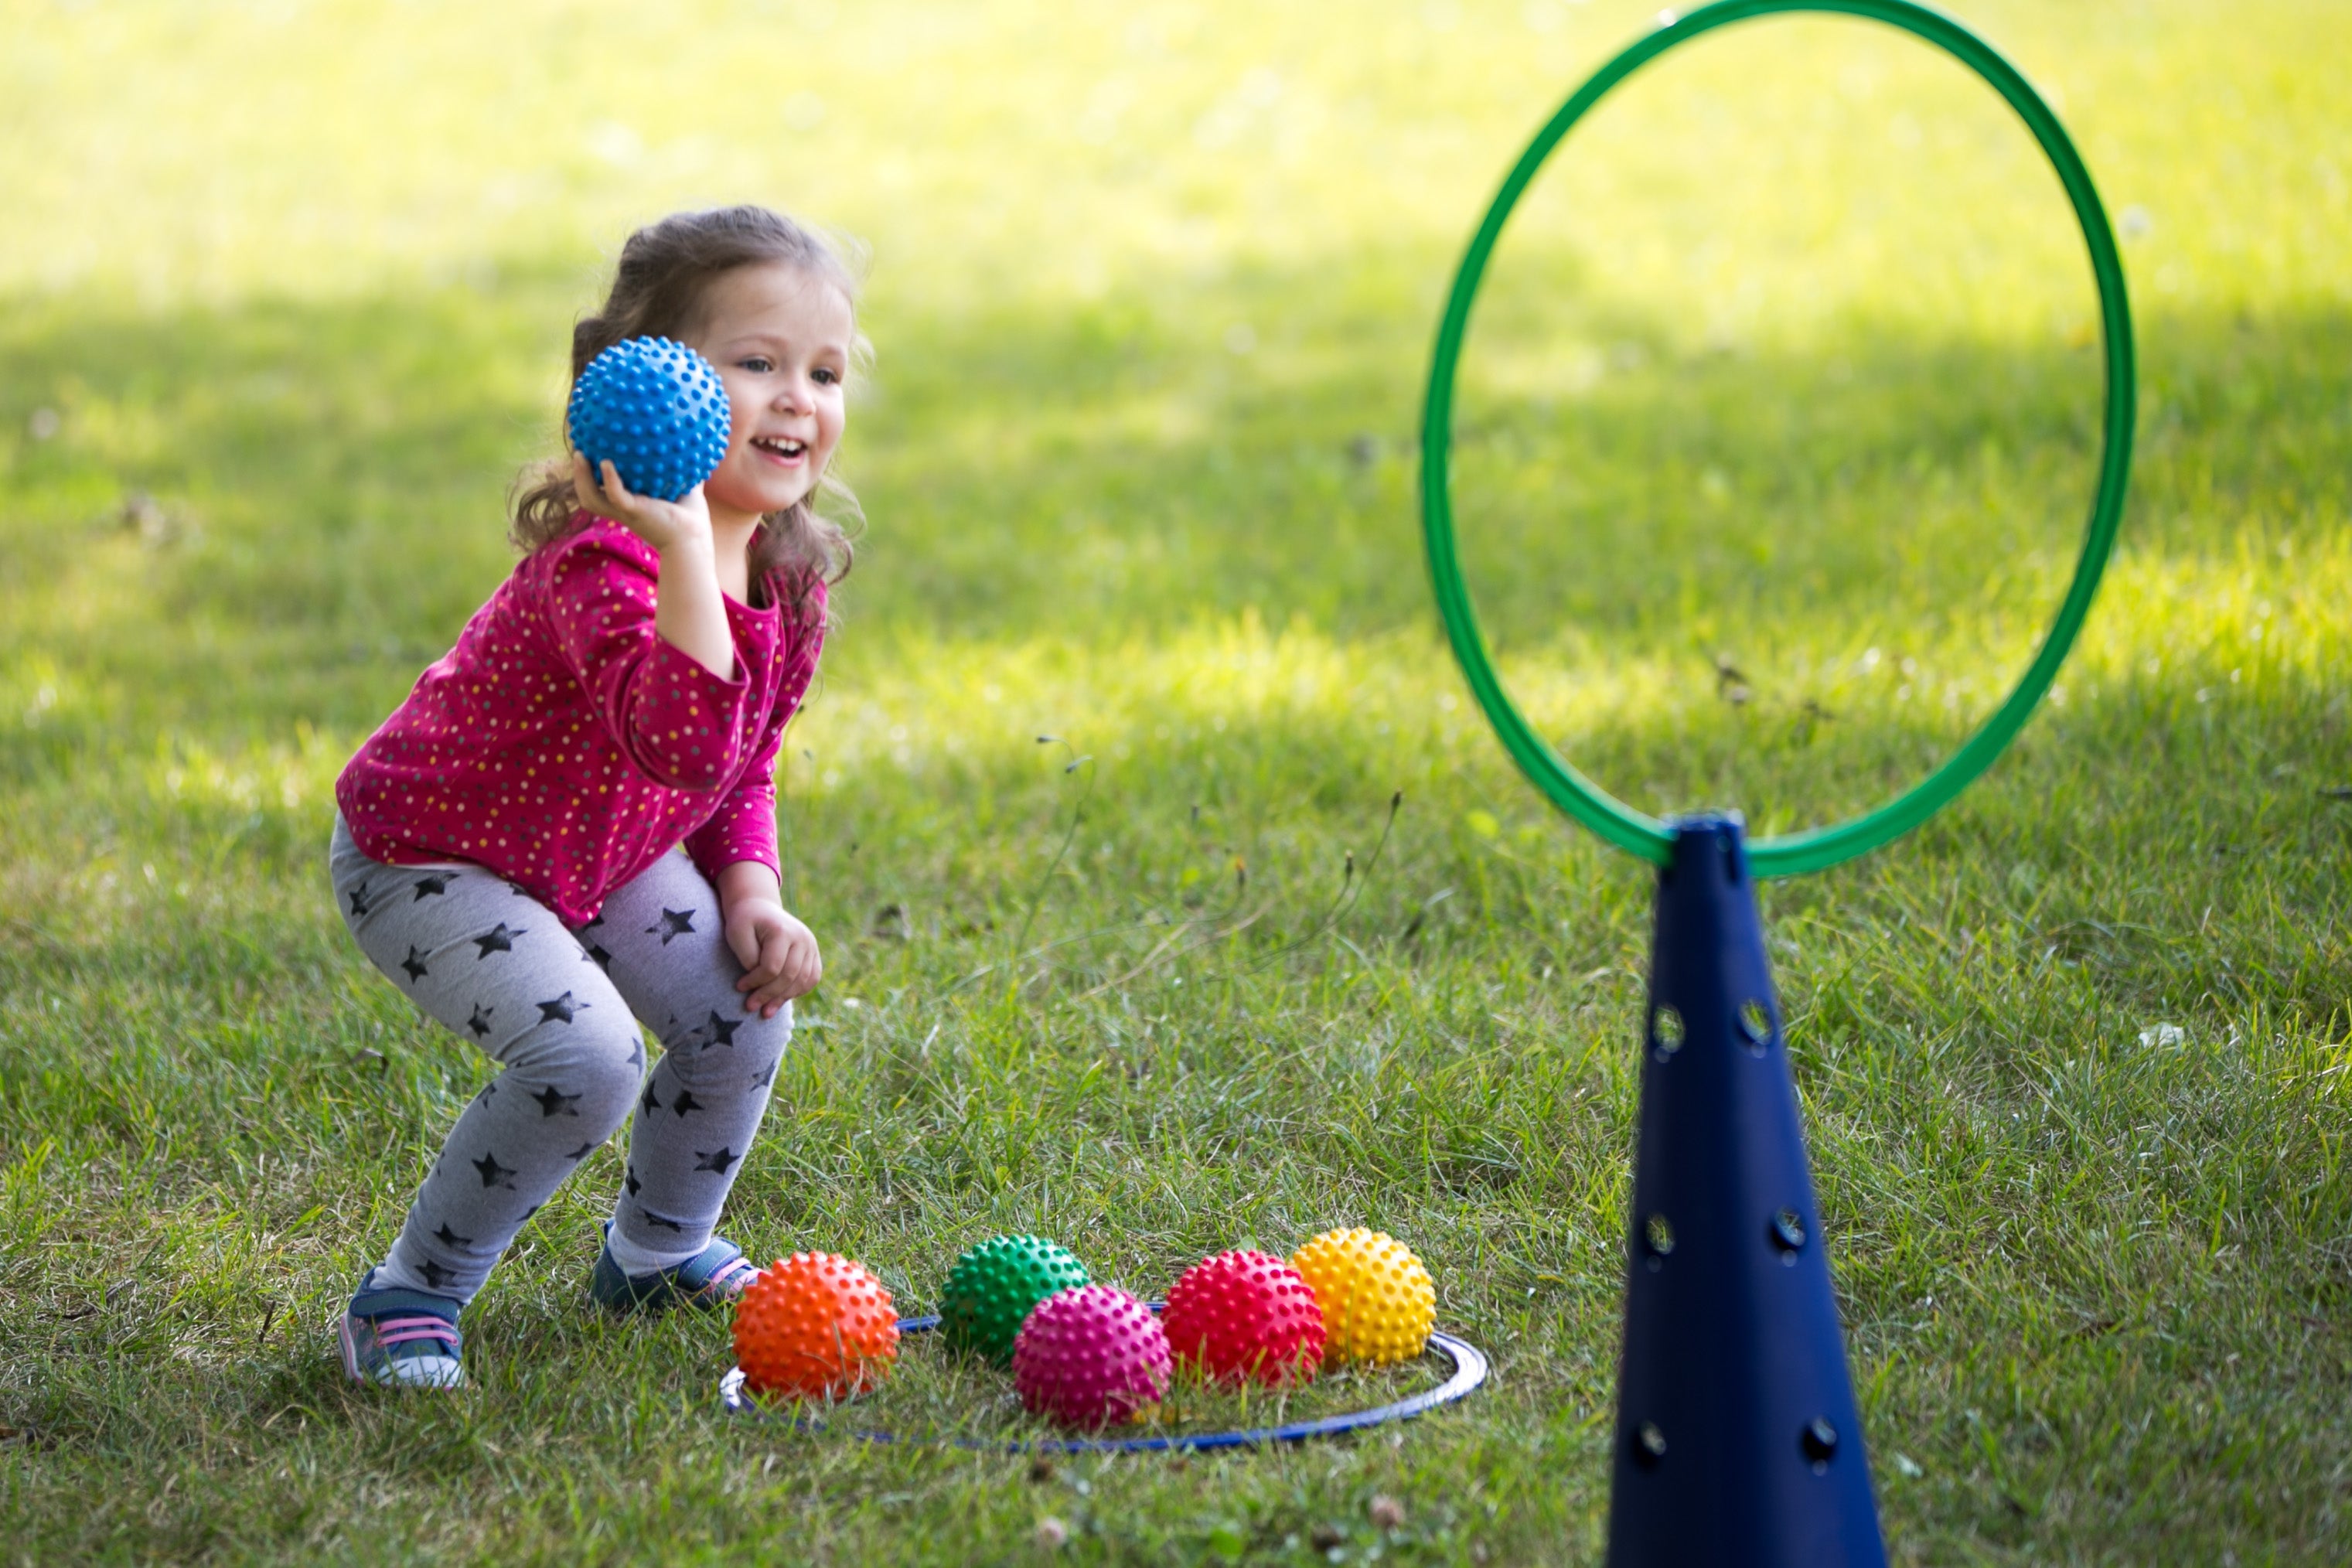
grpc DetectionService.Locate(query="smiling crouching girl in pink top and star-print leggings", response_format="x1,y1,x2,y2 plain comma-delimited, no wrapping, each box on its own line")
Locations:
332,207,861,1387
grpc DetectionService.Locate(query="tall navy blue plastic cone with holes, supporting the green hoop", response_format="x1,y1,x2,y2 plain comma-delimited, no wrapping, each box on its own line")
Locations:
1609,816,1887,1568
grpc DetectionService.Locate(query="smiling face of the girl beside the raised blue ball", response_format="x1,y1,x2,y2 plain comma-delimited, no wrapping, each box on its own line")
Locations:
691,264,856,524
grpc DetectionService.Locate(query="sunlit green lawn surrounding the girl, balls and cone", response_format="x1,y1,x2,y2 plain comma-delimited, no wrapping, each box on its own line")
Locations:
0,0,2352,1563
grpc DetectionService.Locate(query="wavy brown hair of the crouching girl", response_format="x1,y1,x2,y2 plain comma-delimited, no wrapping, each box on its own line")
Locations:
508,207,868,612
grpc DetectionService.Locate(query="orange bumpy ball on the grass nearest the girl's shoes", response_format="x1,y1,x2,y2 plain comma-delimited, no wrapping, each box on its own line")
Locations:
734,1253,898,1399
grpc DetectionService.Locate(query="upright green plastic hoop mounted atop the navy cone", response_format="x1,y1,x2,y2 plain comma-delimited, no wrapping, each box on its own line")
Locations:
1420,0,2133,877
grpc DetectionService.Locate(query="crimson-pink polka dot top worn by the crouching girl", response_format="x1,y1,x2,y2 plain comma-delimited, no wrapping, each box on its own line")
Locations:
334,513,826,926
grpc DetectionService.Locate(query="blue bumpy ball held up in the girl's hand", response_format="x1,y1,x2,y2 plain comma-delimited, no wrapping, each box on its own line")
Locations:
564,339,734,501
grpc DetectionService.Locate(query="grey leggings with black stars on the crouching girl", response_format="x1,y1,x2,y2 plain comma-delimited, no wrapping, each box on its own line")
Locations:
329,816,793,1302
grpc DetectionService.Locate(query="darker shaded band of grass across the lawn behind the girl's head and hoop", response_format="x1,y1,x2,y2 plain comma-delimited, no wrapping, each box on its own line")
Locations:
0,256,2352,757
